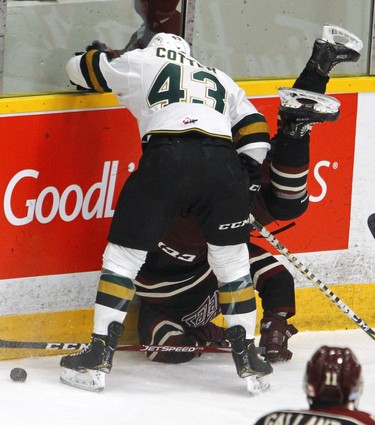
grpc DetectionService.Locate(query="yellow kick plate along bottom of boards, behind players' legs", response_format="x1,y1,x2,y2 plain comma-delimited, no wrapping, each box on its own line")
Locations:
0,283,375,360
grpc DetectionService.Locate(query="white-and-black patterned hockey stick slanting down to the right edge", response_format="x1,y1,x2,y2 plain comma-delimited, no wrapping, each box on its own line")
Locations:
249,214,375,339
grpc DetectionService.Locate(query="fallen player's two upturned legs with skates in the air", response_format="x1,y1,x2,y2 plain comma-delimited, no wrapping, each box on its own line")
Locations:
267,25,363,220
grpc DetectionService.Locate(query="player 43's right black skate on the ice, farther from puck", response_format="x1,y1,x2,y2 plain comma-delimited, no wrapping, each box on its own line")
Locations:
226,325,273,394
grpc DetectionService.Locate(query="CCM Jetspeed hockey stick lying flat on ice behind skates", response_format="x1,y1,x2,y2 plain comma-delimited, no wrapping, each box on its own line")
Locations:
0,339,232,353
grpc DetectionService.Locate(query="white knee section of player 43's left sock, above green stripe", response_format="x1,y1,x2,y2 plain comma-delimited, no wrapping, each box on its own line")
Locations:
103,242,147,280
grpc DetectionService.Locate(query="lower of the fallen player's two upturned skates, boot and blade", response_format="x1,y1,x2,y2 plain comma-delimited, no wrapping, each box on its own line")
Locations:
278,87,340,139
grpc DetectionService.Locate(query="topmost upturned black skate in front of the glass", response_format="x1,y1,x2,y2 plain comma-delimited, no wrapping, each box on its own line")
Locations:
309,24,363,77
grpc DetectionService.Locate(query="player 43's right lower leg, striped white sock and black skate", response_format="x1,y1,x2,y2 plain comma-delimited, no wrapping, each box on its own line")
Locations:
208,244,272,394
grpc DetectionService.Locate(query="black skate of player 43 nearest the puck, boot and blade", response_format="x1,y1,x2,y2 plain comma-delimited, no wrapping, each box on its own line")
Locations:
60,322,124,391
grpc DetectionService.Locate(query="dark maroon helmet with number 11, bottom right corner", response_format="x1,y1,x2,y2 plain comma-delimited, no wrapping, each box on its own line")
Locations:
304,346,363,405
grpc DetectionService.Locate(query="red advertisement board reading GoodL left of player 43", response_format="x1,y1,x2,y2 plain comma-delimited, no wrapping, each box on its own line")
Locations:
0,109,141,279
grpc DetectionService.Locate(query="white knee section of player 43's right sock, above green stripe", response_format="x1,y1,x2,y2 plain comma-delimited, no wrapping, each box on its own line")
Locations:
207,243,250,282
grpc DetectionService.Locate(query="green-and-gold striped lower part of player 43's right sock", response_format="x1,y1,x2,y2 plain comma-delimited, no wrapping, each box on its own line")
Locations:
219,275,256,339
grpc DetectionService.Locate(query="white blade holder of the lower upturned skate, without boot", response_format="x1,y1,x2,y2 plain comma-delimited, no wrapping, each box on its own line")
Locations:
278,87,341,114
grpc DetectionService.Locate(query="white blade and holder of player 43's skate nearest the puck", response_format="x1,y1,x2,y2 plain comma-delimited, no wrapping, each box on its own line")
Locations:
60,367,105,392
